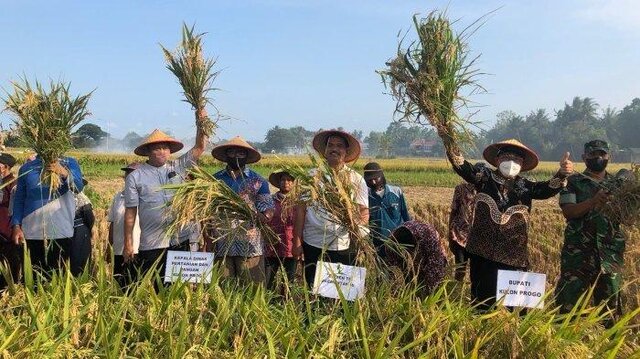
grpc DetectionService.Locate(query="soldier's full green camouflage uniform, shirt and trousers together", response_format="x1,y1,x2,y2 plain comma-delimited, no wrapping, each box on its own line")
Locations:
556,172,625,314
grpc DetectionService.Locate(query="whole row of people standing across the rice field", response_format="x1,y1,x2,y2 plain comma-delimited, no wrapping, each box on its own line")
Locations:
0,126,625,320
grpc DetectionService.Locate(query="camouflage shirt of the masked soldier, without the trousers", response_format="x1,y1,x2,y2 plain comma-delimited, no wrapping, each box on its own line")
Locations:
560,171,625,274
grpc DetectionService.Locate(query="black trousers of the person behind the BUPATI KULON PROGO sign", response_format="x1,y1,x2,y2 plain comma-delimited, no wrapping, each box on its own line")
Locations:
468,253,527,310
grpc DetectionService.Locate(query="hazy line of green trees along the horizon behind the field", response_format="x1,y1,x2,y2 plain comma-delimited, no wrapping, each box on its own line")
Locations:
4,97,640,161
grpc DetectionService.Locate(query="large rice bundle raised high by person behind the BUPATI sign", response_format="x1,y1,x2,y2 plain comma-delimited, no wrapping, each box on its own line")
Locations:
378,11,484,162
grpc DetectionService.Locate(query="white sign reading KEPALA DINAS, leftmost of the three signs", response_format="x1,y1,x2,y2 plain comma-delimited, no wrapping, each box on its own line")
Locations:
164,251,213,283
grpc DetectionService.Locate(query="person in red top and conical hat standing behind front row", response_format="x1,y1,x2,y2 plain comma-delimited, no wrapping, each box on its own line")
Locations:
265,171,297,289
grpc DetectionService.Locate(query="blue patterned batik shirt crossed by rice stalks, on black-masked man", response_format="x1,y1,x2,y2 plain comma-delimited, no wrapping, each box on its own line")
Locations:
213,168,274,257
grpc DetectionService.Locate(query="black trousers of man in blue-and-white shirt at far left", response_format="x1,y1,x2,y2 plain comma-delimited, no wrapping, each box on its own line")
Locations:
27,238,73,278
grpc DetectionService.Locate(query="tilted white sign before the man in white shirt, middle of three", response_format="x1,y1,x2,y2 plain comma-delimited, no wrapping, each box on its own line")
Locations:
313,261,367,301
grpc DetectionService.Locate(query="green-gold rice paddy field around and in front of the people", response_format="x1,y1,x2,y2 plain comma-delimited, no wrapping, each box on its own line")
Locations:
0,153,640,358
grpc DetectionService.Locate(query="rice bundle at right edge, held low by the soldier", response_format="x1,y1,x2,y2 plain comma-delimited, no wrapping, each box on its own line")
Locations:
602,164,640,226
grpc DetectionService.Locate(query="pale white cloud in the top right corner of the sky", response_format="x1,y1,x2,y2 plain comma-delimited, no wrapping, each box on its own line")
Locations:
577,0,640,31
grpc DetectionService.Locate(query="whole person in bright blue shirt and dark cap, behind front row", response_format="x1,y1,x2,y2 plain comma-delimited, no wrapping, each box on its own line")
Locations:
364,162,411,258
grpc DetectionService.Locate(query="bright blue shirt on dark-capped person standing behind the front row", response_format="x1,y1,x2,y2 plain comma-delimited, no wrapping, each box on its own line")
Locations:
369,185,411,246
